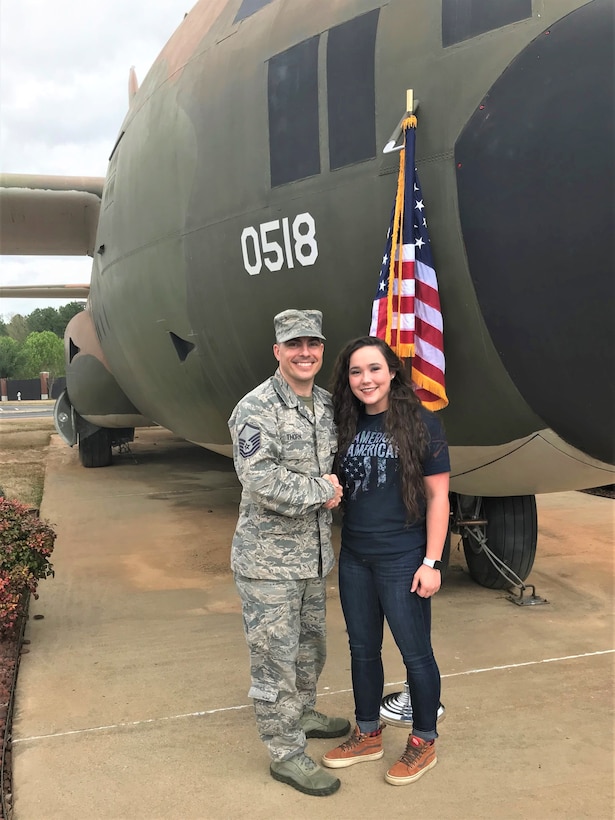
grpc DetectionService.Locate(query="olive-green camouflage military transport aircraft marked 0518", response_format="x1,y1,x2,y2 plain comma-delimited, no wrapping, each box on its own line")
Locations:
1,0,615,588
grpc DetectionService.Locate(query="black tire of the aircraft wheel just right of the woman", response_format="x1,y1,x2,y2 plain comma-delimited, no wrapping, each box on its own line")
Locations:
462,495,537,589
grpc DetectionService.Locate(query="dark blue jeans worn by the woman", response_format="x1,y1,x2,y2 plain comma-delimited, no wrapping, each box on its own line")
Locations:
339,547,440,740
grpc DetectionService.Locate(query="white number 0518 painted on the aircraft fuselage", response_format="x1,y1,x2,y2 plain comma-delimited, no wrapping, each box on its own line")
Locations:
241,213,318,276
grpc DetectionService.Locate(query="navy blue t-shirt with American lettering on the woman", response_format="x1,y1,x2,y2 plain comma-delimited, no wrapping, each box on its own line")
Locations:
340,407,450,555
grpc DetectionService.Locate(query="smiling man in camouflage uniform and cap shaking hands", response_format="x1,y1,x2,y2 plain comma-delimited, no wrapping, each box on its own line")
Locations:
229,310,350,795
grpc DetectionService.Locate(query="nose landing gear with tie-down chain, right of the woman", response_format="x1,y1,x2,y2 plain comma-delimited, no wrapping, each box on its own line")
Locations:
453,494,537,589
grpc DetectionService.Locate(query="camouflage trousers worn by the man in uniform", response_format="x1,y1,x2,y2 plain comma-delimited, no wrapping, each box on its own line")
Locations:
235,575,326,760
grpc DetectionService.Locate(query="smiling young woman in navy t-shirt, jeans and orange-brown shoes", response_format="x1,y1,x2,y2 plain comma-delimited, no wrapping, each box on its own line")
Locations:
323,336,450,786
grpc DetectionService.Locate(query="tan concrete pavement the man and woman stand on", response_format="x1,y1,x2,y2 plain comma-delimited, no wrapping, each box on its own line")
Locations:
13,429,615,820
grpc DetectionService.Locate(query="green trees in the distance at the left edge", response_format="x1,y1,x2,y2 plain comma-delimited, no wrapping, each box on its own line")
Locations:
0,302,85,379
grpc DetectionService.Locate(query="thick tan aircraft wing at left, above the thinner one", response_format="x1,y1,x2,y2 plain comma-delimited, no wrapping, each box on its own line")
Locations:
0,174,104,256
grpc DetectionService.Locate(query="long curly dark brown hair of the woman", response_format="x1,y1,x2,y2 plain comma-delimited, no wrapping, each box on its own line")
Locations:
329,336,429,520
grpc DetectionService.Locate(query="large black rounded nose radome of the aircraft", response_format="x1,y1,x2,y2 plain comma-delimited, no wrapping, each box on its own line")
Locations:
455,0,615,463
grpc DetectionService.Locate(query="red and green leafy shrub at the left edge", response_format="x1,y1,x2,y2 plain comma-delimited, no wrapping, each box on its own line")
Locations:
0,497,56,633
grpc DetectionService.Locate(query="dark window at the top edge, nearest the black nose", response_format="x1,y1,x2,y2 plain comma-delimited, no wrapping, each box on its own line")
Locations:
442,0,532,47
